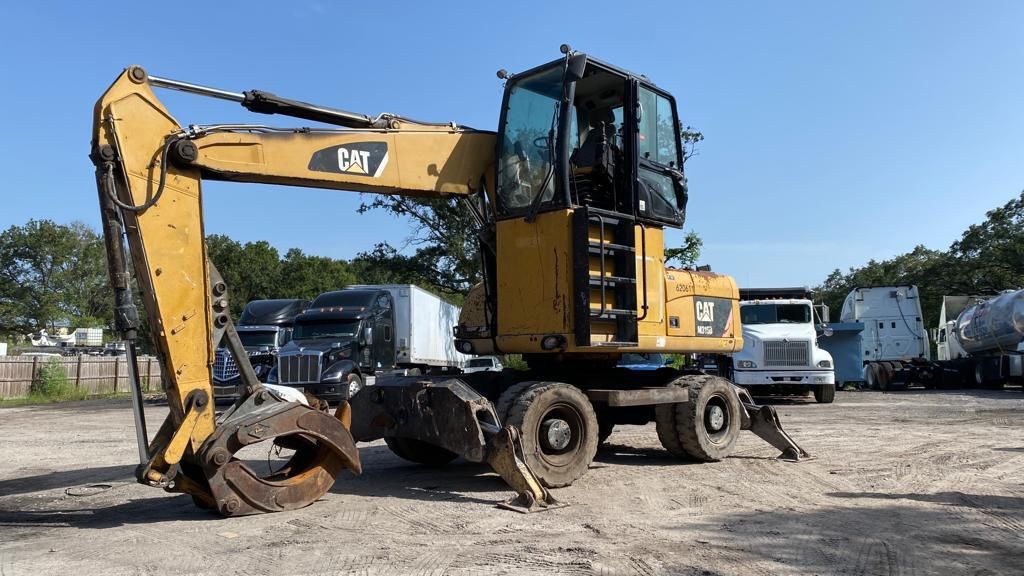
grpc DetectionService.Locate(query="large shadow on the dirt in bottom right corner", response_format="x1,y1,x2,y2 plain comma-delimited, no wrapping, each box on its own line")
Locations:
662,492,1024,576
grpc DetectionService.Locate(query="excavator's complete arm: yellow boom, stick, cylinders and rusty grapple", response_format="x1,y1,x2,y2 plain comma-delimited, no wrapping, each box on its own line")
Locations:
92,67,512,516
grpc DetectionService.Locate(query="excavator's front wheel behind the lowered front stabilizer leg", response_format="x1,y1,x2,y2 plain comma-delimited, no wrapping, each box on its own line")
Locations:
504,382,597,488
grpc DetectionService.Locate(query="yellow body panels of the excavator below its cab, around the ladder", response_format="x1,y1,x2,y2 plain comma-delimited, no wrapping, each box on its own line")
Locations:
491,210,742,356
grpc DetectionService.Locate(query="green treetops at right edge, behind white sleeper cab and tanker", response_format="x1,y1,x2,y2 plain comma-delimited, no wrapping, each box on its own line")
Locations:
817,193,1024,325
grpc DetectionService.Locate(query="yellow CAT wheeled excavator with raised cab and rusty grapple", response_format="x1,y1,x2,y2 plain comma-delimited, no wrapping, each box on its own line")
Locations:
91,46,807,516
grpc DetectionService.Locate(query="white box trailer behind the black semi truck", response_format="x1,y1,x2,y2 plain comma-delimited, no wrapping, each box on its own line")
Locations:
347,284,471,368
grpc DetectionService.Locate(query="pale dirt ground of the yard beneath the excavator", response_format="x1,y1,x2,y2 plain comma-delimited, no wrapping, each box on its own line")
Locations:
0,389,1024,576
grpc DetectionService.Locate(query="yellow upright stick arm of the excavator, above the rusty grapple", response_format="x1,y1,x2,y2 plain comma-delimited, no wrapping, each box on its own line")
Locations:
93,72,214,457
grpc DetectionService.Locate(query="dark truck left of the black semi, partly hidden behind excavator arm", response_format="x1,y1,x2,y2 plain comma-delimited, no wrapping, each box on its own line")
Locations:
213,299,309,402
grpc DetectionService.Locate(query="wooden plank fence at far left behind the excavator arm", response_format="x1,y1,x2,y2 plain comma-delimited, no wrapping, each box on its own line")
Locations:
0,356,163,398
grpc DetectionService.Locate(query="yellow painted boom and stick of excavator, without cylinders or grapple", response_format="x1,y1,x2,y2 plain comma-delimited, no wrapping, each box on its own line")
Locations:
93,66,495,475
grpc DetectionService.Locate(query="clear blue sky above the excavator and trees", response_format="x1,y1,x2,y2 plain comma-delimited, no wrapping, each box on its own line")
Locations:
0,1,1024,286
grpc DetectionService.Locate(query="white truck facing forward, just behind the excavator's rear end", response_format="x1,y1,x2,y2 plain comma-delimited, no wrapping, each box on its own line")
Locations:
731,288,836,404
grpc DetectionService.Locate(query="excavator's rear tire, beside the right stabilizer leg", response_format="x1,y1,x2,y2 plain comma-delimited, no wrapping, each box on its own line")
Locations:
654,375,742,462
